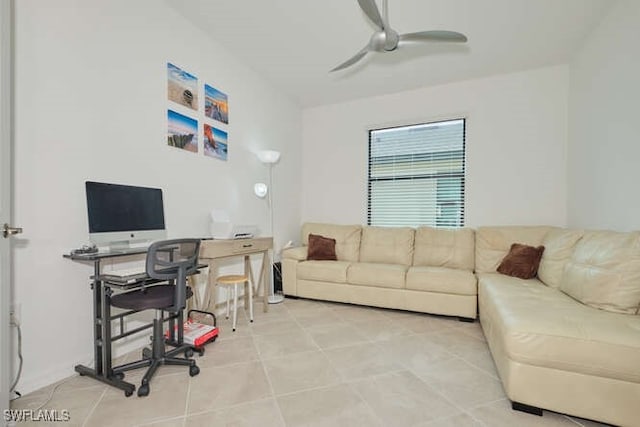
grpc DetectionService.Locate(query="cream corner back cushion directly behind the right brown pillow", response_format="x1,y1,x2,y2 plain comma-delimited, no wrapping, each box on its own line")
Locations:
476,226,554,273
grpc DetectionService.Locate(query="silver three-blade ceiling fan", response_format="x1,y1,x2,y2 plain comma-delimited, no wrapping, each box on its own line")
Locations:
330,0,467,72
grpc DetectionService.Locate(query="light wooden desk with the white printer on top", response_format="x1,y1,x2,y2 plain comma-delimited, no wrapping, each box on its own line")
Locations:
194,237,273,313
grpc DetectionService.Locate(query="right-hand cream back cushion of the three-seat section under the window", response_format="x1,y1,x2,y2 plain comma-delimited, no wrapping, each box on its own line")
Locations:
413,227,476,271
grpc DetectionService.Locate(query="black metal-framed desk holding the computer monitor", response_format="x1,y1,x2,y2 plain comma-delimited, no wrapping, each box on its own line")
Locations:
63,248,199,396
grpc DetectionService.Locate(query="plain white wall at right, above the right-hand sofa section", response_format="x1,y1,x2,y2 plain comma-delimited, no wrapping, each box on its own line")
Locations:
568,0,640,231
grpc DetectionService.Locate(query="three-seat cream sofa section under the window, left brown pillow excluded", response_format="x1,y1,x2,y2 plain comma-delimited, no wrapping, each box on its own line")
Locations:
282,223,477,320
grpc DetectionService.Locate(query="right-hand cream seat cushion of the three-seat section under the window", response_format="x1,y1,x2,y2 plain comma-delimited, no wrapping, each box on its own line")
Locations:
407,267,478,295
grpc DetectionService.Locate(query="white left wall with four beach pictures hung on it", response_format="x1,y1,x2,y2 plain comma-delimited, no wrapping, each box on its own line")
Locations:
13,0,302,392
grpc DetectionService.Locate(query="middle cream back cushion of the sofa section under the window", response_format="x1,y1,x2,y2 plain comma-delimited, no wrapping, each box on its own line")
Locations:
360,227,415,266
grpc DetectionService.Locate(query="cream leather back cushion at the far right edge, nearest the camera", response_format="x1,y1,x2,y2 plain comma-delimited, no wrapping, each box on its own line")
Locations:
560,231,640,314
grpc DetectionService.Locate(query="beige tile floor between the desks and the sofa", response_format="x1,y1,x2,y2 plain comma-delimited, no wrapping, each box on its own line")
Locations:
12,299,600,427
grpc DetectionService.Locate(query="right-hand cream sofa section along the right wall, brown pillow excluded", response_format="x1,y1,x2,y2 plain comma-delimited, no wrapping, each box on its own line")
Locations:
475,227,640,426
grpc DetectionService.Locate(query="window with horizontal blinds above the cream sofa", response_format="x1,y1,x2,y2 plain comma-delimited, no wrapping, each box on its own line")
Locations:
367,119,465,227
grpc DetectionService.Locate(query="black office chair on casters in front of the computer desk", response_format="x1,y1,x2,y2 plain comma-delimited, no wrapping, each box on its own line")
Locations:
111,239,200,396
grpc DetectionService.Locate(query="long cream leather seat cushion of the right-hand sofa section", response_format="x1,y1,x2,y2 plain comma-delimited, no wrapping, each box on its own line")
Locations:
478,274,640,382
